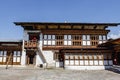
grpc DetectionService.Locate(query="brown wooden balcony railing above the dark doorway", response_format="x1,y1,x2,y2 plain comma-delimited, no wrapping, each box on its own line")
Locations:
24,40,38,49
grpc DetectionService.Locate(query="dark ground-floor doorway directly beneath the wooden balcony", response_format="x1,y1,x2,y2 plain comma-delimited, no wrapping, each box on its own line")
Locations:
26,51,36,65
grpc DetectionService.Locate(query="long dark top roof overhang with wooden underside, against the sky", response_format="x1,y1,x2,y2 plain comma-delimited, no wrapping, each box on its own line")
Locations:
14,22,120,30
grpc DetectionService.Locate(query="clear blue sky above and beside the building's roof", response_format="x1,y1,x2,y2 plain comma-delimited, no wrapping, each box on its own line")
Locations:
0,0,120,39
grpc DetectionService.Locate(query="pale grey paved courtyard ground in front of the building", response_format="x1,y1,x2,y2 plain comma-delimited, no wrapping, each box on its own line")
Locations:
0,68,120,80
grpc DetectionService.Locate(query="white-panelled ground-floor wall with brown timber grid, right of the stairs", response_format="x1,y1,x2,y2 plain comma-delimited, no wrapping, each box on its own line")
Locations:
64,53,113,70
